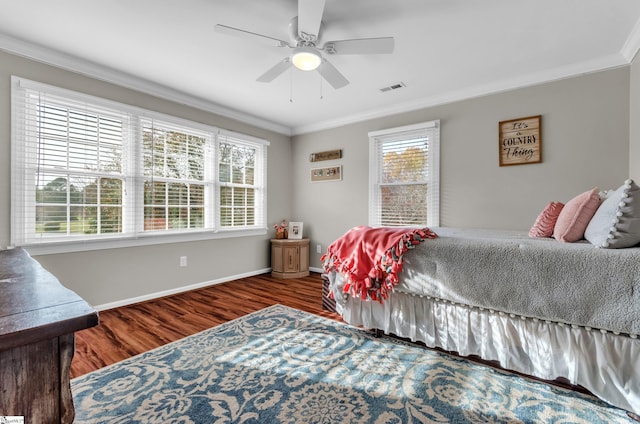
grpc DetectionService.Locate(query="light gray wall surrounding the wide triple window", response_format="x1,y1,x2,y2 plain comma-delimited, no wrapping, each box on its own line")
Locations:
0,52,292,305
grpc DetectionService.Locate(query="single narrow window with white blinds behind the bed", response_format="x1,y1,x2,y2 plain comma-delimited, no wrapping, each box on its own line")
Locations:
369,121,440,227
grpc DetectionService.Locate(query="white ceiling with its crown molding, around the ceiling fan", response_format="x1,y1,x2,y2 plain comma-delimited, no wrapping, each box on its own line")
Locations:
0,0,640,134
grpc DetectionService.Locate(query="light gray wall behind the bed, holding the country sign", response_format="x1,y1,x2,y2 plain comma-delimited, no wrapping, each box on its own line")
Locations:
292,67,630,268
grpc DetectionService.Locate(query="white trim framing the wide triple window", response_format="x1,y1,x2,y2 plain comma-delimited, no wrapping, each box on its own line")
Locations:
10,76,270,255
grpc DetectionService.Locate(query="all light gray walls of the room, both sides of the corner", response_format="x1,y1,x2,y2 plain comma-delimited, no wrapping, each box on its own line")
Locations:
0,48,640,305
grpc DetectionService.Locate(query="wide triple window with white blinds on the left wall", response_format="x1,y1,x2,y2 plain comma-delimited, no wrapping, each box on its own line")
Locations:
11,77,268,252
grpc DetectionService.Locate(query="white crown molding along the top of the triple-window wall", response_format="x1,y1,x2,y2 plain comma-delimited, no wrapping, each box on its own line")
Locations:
0,33,291,136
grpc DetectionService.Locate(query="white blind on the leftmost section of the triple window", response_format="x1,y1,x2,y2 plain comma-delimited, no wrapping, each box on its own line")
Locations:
11,81,131,245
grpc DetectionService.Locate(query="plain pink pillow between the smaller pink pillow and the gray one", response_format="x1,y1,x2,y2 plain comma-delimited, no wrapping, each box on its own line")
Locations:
553,188,601,243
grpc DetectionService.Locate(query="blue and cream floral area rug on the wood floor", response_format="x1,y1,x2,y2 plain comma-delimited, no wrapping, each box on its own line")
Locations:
71,305,632,424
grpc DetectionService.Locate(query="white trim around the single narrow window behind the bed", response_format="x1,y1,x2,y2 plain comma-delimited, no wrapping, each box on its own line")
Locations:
368,120,440,227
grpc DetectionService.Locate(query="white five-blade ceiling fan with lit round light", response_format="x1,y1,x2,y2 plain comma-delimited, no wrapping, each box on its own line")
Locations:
215,0,394,89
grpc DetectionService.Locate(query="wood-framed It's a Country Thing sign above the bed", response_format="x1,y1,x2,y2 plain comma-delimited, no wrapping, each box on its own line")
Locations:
498,115,542,166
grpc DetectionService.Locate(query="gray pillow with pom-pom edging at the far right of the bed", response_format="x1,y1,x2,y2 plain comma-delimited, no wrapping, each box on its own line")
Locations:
584,180,640,249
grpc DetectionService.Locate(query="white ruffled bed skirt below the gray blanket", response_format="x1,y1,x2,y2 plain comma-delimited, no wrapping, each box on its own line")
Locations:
337,291,640,414
